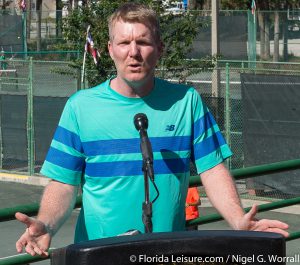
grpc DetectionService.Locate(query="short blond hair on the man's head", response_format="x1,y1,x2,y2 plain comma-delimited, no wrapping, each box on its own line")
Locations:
108,2,161,41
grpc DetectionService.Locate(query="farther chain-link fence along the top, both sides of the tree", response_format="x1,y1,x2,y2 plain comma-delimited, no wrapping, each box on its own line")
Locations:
0,10,300,62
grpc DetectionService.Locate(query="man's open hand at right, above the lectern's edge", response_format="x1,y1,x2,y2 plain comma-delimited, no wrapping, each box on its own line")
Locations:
238,205,289,237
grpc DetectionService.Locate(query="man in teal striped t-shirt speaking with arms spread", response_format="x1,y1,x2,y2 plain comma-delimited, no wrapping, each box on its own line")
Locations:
16,3,288,255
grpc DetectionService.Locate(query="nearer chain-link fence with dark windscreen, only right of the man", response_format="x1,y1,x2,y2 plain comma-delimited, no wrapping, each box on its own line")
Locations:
162,60,300,199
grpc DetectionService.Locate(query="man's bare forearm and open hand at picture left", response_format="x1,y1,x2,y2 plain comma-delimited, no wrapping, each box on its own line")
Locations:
16,180,78,256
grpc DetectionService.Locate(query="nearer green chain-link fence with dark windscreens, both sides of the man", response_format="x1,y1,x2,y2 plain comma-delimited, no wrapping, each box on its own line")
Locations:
0,60,300,198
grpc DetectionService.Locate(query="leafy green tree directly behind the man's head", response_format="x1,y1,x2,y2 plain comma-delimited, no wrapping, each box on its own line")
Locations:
63,0,211,85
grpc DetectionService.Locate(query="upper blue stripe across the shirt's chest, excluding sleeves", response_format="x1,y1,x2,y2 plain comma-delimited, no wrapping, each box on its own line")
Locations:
82,136,191,156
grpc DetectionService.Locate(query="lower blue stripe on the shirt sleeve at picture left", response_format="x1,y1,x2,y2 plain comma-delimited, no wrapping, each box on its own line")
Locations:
46,147,85,171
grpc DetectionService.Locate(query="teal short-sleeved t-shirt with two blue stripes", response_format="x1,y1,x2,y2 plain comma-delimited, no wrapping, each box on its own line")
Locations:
41,78,231,242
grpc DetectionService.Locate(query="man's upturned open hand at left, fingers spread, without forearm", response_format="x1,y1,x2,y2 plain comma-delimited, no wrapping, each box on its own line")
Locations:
15,212,52,257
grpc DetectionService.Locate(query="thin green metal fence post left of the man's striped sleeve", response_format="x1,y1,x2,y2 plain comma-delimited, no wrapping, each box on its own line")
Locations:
27,57,34,176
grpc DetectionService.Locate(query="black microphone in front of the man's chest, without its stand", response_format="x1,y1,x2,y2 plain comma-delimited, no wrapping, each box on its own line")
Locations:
133,113,154,181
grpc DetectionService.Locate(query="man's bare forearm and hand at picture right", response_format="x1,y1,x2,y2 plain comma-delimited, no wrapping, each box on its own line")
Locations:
201,163,289,237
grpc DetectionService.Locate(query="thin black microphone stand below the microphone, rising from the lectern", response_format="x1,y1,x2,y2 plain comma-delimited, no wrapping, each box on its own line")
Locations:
142,159,153,233
